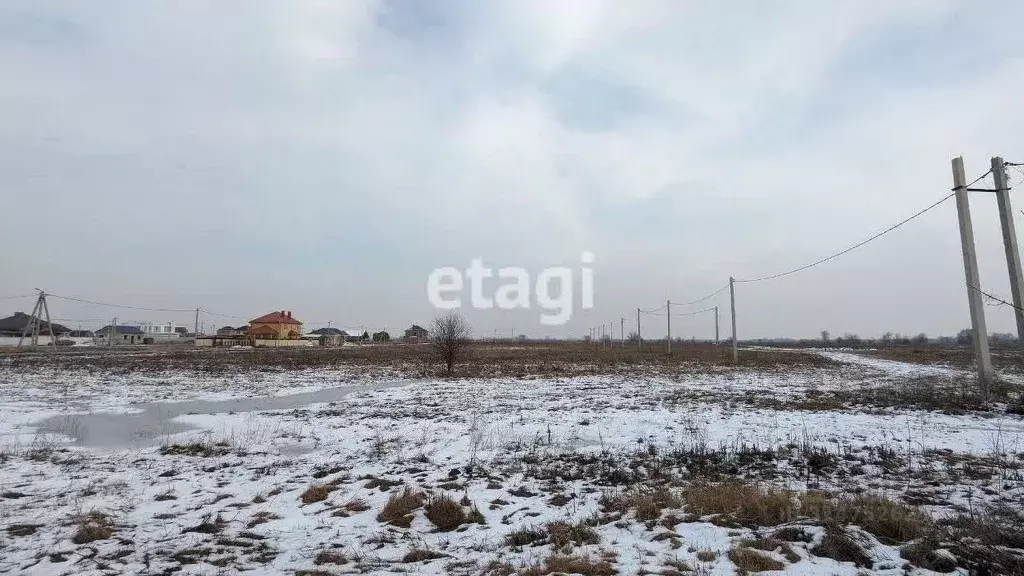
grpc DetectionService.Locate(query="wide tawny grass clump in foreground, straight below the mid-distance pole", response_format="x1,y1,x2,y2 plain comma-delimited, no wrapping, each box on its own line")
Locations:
683,483,796,527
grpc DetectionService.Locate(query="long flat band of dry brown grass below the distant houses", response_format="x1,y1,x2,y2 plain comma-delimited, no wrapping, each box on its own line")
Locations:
0,341,831,377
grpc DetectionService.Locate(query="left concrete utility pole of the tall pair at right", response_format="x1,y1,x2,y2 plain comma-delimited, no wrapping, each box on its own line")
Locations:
952,157,993,402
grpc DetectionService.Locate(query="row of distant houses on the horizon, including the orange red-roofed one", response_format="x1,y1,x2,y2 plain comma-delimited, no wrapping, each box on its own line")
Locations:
0,311,429,346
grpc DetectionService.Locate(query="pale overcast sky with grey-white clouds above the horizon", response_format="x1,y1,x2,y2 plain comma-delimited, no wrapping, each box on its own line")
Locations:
0,0,1024,338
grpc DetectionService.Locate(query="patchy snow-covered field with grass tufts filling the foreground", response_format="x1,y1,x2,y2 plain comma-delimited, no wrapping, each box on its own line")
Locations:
0,353,1024,576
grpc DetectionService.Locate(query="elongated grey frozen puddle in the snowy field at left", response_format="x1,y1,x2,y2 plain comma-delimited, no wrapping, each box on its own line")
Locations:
30,380,415,449
